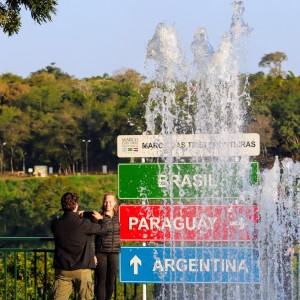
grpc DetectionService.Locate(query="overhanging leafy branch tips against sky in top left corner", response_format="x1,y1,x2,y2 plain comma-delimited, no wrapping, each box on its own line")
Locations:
0,0,57,36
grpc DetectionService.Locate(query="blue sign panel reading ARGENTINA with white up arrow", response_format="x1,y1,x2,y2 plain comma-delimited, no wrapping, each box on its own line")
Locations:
120,247,259,283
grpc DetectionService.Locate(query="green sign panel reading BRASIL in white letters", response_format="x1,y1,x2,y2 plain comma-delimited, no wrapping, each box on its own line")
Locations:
118,162,258,199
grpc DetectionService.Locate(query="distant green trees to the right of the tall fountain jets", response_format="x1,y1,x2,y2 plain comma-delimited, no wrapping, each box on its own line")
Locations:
248,72,300,167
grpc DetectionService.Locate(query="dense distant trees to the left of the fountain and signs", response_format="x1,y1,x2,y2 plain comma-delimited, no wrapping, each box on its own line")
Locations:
0,67,149,174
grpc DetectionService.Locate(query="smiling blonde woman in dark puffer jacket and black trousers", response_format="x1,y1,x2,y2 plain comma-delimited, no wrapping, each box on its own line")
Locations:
95,192,120,300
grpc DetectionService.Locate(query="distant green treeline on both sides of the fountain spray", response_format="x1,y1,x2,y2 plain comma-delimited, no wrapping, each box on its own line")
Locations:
0,64,300,174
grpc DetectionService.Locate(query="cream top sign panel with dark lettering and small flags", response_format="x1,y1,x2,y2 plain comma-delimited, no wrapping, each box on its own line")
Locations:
117,133,260,157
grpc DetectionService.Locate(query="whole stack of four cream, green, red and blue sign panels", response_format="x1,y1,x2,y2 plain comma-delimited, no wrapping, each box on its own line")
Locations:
117,133,260,288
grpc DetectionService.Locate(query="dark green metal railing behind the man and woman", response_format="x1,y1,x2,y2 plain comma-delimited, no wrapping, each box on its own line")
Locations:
0,237,141,300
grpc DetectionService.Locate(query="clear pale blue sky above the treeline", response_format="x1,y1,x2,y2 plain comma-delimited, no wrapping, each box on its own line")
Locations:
0,0,300,79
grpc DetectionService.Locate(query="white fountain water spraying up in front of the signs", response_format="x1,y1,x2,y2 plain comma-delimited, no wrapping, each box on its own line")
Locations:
145,2,300,299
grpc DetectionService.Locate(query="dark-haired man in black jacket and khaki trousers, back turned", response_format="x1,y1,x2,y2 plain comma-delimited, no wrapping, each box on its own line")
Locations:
51,193,107,300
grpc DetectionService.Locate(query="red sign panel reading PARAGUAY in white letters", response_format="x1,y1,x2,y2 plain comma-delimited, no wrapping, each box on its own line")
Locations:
120,205,258,242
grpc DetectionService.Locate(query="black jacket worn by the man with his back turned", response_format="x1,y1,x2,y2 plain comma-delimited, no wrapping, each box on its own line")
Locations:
51,211,107,270
